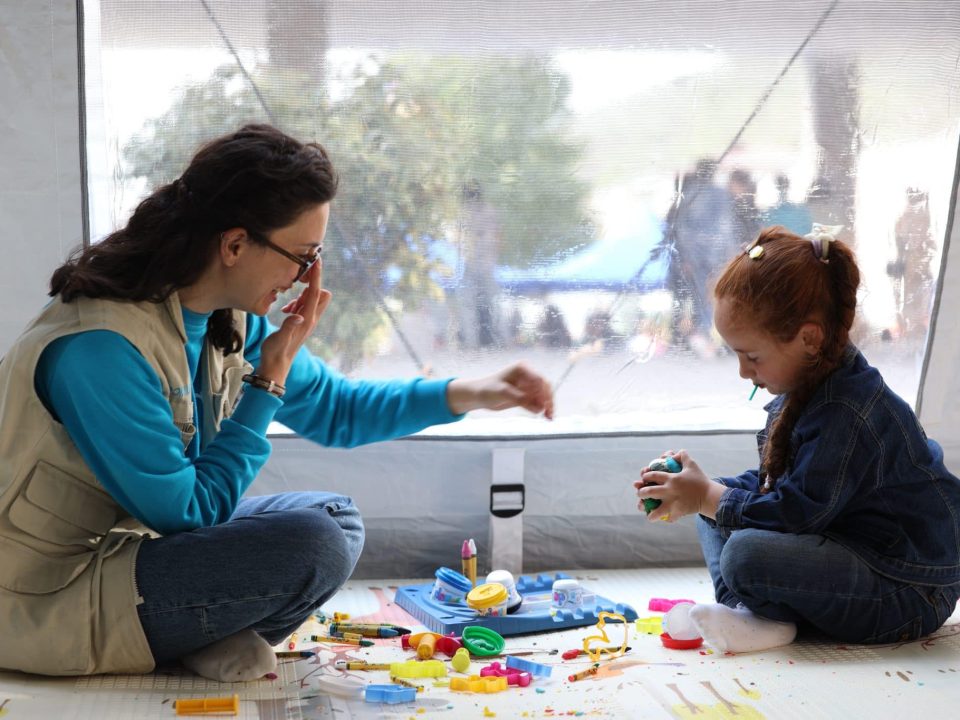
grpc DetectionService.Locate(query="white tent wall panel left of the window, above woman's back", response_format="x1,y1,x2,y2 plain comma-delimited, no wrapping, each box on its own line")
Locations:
0,0,84,353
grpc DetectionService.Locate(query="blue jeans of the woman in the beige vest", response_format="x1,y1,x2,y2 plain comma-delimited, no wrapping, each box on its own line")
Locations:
136,492,363,664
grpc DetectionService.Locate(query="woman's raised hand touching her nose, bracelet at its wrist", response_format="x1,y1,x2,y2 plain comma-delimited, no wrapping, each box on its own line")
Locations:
256,260,332,385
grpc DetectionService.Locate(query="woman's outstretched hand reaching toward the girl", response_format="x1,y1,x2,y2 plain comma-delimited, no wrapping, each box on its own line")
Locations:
447,363,553,420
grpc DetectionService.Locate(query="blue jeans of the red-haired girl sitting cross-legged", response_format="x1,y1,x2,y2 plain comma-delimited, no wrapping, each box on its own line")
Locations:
697,516,960,644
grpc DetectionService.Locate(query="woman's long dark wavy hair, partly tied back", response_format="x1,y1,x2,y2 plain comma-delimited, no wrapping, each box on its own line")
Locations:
50,125,338,353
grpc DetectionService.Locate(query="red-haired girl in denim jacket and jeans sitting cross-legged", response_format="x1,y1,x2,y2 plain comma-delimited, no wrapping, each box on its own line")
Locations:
634,227,960,652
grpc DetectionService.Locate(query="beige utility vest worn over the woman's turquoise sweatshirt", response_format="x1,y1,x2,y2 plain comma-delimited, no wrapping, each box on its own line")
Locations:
0,293,250,675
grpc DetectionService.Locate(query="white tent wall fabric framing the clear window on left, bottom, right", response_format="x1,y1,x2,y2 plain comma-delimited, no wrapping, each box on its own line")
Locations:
0,0,960,577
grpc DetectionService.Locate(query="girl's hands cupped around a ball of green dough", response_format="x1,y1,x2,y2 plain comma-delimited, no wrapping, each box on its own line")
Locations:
633,450,724,522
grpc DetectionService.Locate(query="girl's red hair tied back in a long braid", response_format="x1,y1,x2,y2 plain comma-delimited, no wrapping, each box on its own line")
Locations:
713,225,860,491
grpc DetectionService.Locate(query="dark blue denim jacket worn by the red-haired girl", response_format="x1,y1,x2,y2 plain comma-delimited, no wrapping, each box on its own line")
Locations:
716,345,960,585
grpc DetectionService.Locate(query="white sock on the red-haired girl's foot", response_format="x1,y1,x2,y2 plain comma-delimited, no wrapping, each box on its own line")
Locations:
690,603,797,652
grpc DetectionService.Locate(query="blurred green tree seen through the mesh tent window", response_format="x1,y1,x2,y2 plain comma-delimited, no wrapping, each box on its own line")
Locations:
123,55,588,372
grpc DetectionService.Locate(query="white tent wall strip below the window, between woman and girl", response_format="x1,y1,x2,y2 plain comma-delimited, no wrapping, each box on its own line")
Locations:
251,433,756,577
